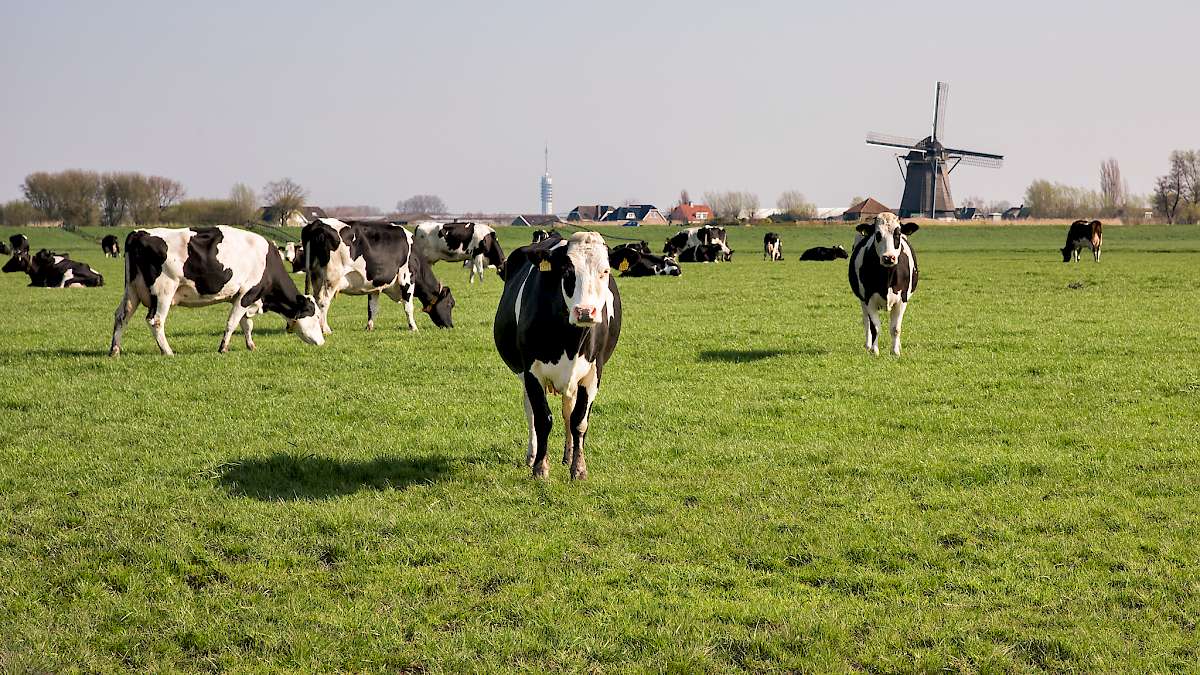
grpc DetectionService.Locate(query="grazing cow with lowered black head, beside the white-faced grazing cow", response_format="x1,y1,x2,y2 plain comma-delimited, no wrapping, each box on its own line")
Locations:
300,217,455,335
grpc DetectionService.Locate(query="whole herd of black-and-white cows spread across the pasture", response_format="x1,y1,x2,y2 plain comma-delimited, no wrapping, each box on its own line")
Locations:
0,213,1103,478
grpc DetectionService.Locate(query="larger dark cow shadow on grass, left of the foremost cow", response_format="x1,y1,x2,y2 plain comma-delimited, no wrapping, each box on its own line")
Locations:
214,453,451,501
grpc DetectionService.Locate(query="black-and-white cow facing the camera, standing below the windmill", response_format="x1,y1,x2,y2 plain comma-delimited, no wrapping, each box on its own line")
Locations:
850,213,918,357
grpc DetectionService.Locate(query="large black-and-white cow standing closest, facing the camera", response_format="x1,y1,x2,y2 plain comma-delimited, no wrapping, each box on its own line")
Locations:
493,232,620,479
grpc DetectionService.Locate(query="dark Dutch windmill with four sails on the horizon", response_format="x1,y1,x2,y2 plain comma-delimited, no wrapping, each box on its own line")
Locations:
866,82,1004,217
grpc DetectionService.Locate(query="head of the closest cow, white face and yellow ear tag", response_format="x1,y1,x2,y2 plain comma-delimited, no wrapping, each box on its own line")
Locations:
529,232,612,328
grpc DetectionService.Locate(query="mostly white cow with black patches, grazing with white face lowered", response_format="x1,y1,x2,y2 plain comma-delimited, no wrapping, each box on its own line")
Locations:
109,226,325,357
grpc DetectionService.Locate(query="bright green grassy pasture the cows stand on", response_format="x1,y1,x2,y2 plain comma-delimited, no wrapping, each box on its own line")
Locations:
0,226,1200,673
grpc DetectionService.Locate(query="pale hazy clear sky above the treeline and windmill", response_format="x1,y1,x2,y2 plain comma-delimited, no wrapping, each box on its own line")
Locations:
0,0,1200,213
